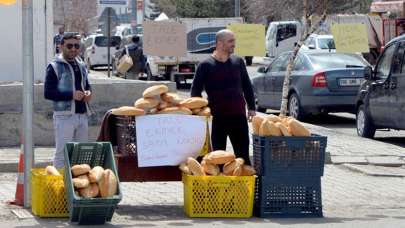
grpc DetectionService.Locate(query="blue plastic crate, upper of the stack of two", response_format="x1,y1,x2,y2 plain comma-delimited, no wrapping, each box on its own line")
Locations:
253,135,327,177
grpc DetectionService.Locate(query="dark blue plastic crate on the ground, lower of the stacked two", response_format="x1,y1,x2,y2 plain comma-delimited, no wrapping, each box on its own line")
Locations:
254,176,323,218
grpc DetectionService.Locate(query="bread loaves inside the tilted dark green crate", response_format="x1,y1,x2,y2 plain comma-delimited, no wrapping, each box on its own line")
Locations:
72,164,118,198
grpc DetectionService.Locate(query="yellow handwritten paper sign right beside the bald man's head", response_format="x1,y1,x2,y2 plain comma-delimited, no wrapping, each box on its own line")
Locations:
227,24,265,56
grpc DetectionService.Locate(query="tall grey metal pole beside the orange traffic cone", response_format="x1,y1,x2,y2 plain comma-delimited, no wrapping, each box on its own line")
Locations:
22,0,34,208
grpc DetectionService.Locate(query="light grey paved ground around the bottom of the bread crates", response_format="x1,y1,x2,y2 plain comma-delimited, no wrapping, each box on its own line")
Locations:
0,165,405,228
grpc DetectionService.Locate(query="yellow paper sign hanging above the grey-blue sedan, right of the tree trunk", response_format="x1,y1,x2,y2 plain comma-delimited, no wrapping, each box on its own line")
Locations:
331,24,369,53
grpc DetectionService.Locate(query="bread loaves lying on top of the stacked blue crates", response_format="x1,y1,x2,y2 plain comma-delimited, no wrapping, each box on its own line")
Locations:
252,114,311,136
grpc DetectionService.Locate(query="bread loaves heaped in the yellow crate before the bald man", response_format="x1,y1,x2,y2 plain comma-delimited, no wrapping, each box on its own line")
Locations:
179,150,256,176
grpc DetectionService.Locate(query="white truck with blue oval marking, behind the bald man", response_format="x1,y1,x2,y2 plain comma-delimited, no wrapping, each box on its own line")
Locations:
146,17,252,86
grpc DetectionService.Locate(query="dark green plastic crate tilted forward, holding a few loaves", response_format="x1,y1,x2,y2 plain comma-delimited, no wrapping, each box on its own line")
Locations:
64,142,122,225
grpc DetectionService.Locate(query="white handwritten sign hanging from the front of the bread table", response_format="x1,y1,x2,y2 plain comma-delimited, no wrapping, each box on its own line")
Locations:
136,114,207,167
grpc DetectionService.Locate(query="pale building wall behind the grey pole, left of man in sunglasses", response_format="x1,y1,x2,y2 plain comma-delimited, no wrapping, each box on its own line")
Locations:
0,0,53,82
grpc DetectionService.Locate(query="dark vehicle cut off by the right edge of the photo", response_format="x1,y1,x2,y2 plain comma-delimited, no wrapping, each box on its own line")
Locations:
356,35,405,138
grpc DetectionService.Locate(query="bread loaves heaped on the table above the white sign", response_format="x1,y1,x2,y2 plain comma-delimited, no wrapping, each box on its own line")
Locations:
112,85,211,116
